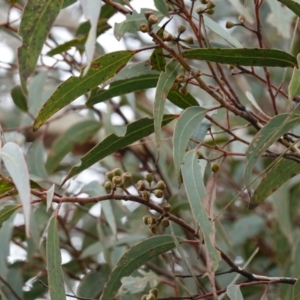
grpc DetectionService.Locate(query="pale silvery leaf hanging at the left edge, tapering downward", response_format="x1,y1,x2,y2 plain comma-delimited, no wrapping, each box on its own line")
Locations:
1,142,31,236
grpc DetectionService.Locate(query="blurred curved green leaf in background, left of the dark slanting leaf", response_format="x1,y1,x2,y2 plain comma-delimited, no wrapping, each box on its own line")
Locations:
45,120,100,173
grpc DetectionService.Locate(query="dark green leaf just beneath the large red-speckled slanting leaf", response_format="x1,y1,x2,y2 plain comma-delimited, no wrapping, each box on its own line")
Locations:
86,74,158,107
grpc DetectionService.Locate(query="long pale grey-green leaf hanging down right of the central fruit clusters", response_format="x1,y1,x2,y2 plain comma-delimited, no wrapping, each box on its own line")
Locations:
181,150,221,271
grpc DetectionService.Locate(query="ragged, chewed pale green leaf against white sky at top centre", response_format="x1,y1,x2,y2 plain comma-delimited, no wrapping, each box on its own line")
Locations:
114,8,164,41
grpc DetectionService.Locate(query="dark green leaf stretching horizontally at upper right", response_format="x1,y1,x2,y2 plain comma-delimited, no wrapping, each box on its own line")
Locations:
182,49,297,67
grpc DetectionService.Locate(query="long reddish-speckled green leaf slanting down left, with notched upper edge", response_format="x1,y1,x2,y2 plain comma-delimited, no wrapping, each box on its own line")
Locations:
33,51,136,130
